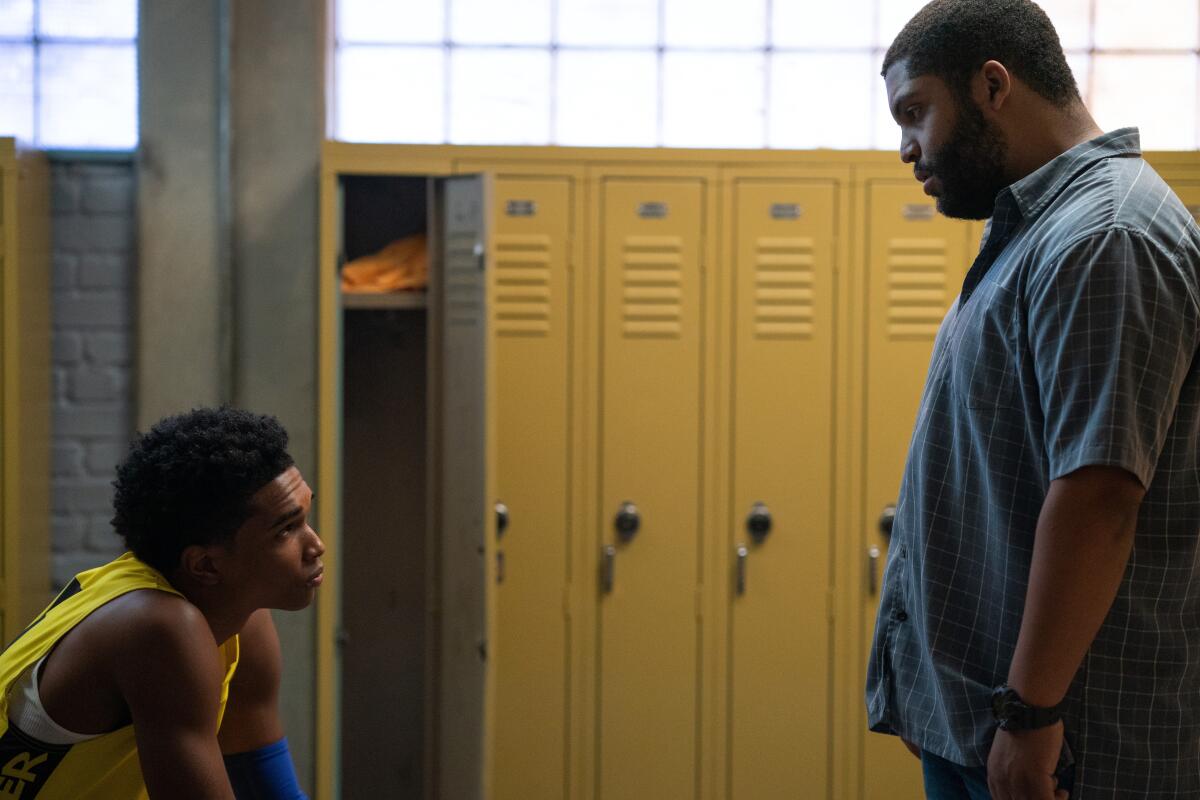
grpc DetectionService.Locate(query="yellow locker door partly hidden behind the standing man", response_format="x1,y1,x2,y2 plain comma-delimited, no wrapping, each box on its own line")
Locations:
860,179,979,800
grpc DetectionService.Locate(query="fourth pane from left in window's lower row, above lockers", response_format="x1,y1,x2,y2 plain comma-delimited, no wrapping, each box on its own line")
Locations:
662,52,766,148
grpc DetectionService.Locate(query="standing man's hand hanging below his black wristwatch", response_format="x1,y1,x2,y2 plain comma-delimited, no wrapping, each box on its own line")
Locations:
988,722,1067,800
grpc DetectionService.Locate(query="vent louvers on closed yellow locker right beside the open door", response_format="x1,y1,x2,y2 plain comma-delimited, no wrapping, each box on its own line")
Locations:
496,235,553,338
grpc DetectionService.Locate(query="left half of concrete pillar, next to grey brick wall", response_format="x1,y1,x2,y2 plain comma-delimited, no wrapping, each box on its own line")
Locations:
137,0,233,429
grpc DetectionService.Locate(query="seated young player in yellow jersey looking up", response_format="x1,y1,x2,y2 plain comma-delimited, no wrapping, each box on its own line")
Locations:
0,408,324,800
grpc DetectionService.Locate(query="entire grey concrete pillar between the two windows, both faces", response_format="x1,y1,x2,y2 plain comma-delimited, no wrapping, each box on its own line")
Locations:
138,0,332,794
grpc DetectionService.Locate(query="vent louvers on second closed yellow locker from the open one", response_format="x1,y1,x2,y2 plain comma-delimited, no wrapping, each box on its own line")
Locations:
622,236,683,339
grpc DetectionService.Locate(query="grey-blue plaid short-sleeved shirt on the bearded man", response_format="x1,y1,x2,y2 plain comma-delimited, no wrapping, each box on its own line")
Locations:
866,128,1200,800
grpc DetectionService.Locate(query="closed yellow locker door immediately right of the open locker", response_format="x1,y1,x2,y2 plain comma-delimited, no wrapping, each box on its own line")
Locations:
492,173,576,800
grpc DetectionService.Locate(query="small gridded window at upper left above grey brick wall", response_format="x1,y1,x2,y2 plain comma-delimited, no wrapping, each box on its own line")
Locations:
0,0,138,150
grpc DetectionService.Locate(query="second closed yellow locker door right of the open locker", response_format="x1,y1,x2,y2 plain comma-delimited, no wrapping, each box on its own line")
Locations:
595,176,707,800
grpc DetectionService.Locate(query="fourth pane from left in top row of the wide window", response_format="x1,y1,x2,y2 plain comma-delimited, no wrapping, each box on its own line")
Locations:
662,0,767,47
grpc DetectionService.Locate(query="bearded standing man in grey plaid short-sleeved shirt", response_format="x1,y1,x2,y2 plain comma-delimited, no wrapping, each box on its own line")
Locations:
866,0,1200,800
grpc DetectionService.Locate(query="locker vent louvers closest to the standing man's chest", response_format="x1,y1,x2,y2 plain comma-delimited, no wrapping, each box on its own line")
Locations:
888,239,948,339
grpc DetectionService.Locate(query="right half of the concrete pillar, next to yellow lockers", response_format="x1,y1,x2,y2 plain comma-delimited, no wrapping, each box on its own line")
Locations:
230,0,324,793
